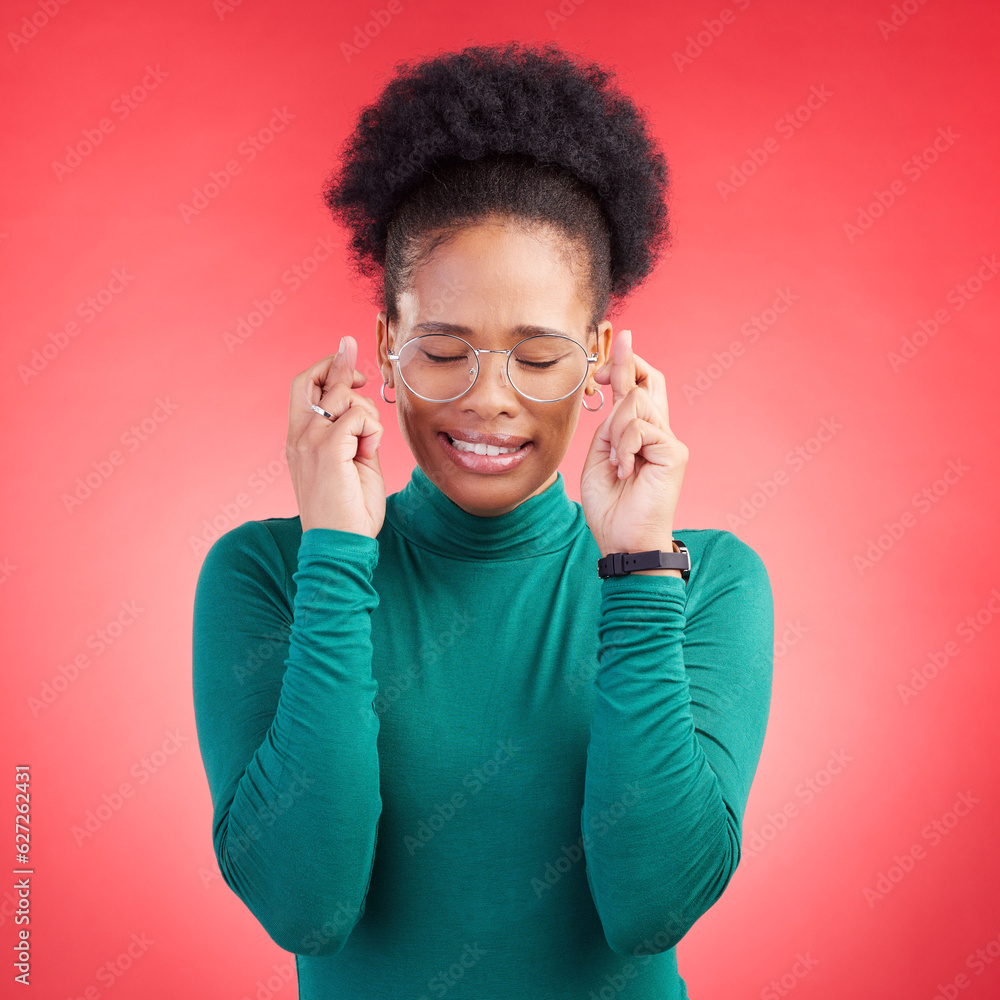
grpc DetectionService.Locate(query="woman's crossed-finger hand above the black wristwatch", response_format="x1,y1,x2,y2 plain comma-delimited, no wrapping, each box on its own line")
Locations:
580,330,688,556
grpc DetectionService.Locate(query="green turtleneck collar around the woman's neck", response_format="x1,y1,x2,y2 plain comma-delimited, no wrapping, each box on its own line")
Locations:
386,465,586,560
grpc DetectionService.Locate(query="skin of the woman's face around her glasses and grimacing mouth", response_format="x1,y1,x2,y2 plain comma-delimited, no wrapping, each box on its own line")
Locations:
376,221,611,517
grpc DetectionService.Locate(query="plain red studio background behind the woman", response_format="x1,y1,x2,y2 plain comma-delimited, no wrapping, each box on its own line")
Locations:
0,0,1000,1000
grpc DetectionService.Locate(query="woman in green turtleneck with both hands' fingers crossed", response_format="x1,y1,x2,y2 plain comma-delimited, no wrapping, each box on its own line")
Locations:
194,43,773,1000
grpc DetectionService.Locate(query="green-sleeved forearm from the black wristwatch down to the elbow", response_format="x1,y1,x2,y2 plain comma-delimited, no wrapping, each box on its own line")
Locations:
581,574,738,954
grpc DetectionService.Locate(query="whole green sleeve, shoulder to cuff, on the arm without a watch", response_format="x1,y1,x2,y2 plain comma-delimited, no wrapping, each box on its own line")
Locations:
193,521,382,955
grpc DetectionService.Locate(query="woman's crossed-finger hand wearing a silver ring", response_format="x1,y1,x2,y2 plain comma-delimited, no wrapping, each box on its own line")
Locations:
285,336,385,538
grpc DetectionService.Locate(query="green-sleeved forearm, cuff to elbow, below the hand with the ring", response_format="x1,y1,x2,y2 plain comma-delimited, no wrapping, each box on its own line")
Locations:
195,530,382,954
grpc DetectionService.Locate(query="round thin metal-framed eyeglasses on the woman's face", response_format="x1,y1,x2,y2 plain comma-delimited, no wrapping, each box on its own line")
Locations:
388,333,597,403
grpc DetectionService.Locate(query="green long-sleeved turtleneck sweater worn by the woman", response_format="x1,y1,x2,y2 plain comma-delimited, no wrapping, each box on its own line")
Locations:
193,466,774,1000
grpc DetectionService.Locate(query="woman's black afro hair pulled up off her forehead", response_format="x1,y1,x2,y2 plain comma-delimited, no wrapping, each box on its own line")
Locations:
323,42,670,328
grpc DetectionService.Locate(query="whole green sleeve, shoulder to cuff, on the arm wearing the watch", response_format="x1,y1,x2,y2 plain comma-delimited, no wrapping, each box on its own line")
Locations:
581,531,774,955
